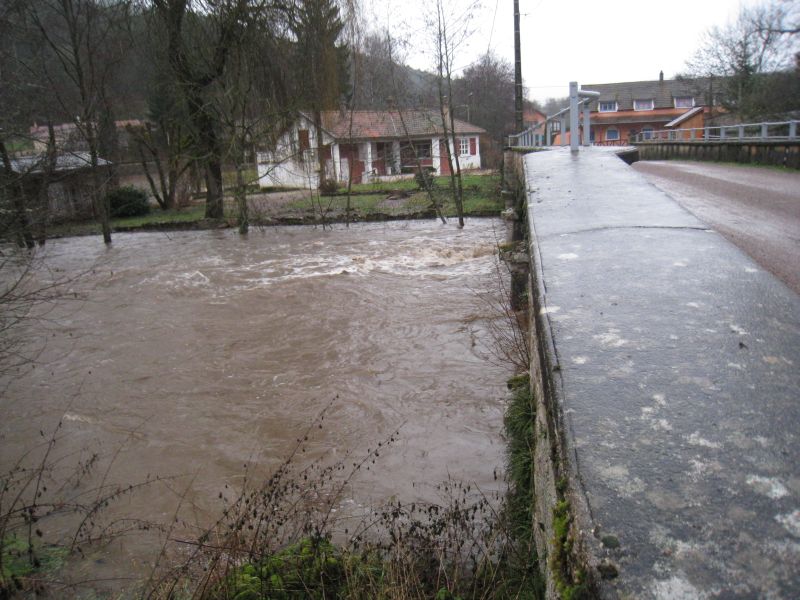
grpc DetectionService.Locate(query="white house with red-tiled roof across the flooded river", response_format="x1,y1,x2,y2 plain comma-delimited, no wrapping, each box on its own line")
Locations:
258,110,486,188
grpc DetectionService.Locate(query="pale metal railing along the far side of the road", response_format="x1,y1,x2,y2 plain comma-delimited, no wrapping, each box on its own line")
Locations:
630,121,800,143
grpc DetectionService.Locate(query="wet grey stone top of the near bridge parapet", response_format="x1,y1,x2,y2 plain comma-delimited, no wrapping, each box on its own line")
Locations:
526,150,800,599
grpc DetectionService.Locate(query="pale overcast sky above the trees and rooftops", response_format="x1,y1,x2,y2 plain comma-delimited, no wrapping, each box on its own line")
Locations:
362,0,758,100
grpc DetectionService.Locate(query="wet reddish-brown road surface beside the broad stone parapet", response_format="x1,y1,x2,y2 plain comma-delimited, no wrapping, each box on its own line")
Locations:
633,161,800,294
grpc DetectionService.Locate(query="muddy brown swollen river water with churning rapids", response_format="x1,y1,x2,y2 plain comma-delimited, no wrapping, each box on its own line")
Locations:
0,219,509,584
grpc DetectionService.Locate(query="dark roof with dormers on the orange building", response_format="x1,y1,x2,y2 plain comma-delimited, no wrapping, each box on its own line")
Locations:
581,79,703,111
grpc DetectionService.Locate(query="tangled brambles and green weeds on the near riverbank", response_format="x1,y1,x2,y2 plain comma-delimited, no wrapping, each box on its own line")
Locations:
0,400,541,600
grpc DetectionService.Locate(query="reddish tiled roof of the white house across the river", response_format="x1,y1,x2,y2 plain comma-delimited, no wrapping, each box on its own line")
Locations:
322,109,486,140
